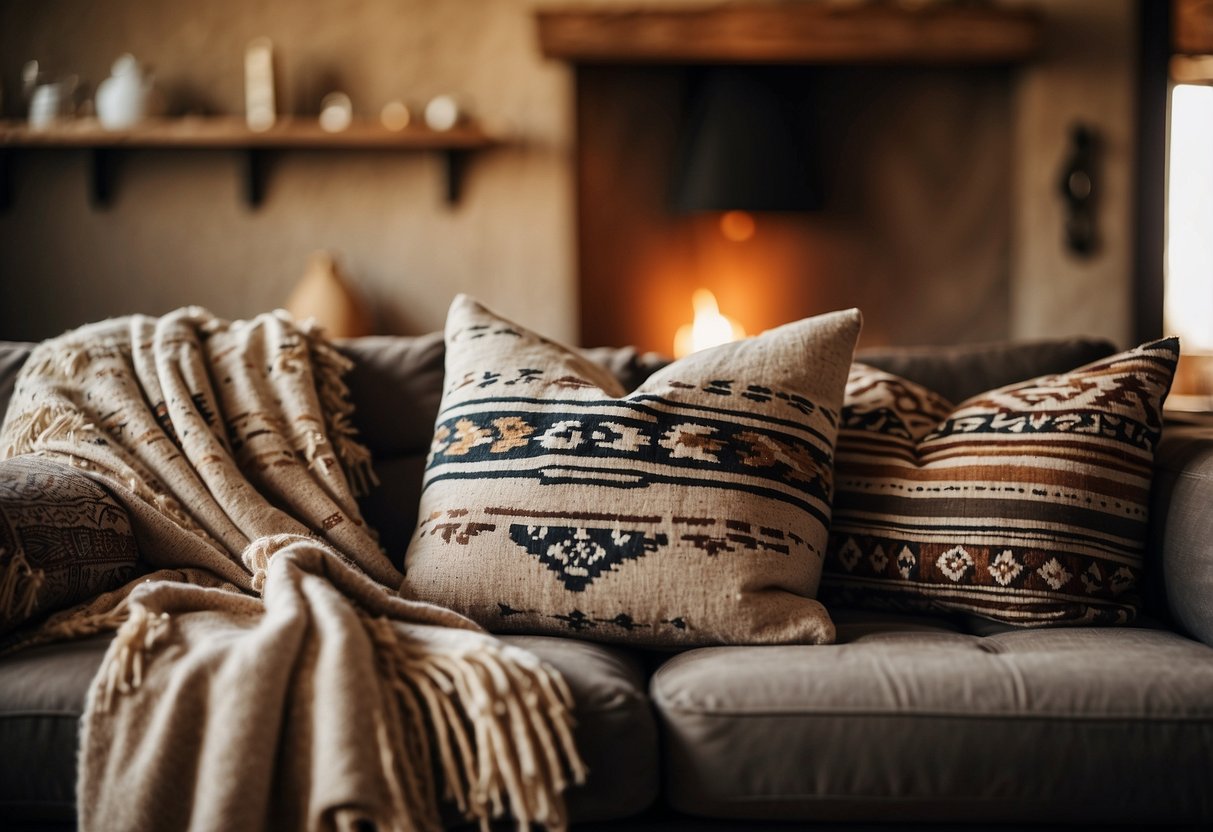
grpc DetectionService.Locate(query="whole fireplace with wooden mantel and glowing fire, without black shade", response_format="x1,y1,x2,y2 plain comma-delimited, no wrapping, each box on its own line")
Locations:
540,4,1040,352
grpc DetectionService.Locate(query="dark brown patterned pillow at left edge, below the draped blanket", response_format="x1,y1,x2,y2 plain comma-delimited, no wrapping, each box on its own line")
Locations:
0,456,138,634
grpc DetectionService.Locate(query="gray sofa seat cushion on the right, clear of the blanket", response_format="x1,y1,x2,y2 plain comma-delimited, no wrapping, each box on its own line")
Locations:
651,614,1213,824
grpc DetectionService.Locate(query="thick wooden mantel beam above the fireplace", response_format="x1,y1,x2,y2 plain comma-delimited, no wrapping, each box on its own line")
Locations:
536,2,1042,64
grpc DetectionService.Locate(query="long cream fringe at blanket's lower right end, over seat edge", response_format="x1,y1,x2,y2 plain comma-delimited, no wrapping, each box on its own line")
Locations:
366,619,587,830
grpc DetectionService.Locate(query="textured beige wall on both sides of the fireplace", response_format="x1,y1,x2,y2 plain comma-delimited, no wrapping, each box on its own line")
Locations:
0,0,1134,342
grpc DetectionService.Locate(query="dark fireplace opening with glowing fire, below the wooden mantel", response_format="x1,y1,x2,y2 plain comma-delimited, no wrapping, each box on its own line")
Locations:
575,64,1014,353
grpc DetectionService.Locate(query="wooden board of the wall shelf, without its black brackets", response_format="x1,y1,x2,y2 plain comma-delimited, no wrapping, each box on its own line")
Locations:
0,116,501,150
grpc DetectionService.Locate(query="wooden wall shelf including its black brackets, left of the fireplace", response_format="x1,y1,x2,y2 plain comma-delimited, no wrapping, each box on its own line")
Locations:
0,116,502,207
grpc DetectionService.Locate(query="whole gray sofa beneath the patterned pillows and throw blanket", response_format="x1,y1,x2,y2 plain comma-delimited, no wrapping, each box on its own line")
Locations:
0,335,1213,828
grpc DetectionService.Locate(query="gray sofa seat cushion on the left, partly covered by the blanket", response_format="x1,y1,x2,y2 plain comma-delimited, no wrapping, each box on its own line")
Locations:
0,636,659,828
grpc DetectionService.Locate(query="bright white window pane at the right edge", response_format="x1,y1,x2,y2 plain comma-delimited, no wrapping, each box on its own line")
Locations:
1164,84,1213,352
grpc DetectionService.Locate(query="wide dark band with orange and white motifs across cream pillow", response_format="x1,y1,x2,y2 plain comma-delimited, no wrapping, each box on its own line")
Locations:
426,395,837,523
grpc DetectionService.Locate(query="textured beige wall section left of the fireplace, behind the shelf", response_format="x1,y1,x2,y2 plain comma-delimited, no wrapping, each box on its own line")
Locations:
0,0,575,338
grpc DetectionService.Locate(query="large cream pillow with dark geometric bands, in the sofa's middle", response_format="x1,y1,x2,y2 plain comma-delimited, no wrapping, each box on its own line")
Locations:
403,296,860,645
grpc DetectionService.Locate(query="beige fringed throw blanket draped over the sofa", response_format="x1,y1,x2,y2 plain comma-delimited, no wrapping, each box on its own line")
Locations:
0,308,583,831
